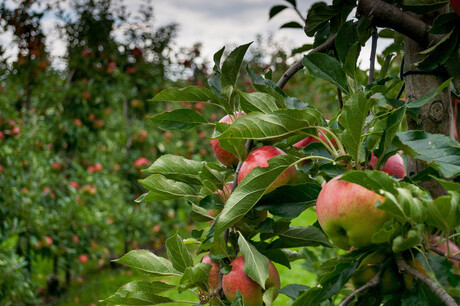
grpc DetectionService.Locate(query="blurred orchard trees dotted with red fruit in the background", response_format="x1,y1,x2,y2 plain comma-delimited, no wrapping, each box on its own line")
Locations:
0,0,316,305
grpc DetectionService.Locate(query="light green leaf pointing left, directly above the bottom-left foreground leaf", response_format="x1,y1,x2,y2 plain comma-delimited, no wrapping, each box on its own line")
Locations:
114,250,182,276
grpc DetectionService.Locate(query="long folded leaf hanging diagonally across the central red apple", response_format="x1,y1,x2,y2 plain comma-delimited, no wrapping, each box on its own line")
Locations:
214,155,298,235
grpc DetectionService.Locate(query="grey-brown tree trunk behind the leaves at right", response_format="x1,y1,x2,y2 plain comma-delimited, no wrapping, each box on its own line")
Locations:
404,9,454,197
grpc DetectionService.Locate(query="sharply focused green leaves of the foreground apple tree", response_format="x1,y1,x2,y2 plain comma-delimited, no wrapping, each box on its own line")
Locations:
105,1,460,305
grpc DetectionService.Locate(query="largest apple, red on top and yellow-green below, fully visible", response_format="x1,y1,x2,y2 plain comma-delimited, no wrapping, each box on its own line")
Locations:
316,177,391,250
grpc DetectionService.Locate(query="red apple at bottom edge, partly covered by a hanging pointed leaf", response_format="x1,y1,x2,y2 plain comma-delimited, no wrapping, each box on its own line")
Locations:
222,256,280,306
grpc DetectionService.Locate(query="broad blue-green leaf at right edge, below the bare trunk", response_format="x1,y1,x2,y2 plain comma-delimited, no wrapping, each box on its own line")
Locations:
396,131,460,178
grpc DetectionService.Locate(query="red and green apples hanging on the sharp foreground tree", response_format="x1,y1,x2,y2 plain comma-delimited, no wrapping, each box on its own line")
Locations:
209,112,460,305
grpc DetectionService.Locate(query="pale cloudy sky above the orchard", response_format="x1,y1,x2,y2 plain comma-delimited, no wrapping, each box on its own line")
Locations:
0,0,383,68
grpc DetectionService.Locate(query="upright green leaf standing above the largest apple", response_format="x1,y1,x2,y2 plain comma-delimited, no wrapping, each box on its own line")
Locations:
339,92,370,163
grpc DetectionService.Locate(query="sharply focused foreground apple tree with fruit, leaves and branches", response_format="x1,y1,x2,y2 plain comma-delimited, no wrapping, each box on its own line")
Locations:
105,0,460,305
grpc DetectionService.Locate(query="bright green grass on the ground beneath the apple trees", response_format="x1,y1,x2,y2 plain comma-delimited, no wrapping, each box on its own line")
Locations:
52,209,316,305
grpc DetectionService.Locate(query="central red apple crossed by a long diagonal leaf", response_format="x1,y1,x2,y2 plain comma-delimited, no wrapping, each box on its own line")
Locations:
238,146,297,193
